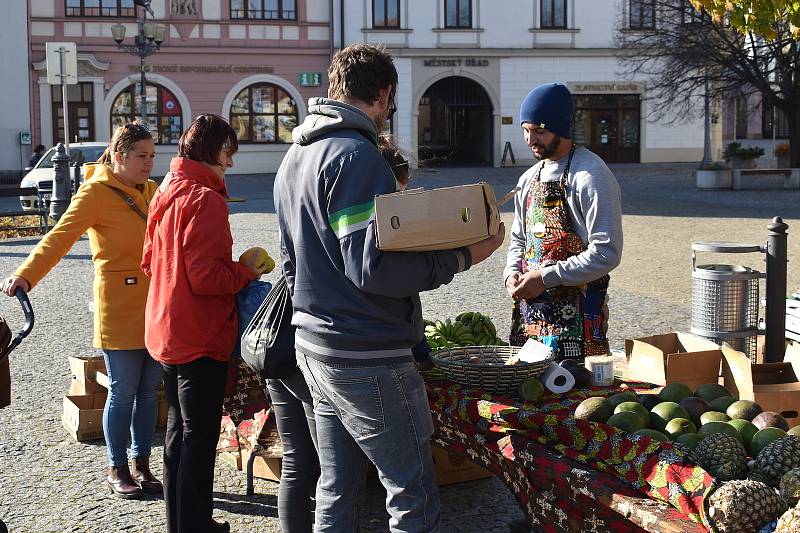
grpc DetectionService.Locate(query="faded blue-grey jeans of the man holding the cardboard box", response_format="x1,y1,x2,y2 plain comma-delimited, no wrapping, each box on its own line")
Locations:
297,352,440,533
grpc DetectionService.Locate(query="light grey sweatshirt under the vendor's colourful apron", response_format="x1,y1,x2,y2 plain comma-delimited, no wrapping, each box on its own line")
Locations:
503,147,622,289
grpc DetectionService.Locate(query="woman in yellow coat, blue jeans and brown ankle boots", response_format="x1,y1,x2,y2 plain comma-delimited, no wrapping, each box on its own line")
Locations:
2,123,162,498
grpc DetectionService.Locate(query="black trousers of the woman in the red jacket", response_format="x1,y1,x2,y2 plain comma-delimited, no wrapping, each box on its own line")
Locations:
162,357,228,533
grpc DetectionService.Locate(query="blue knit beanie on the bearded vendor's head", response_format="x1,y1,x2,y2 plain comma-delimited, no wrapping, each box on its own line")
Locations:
519,83,575,139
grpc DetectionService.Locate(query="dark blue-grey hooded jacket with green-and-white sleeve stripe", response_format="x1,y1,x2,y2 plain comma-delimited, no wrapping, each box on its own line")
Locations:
274,98,471,365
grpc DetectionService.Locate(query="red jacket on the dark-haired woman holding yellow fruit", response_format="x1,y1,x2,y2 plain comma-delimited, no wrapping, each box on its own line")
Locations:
142,157,256,365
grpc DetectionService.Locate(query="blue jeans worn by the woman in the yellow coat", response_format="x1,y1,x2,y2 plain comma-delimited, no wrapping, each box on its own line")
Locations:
103,348,161,466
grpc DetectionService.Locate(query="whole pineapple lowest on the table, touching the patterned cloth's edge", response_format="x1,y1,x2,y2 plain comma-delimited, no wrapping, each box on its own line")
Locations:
706,478,788,533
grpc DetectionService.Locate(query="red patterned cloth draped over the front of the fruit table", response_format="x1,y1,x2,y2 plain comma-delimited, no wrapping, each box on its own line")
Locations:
426,372,713,533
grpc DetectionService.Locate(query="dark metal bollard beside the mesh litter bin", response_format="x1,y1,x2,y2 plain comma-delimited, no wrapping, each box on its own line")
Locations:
764,217,789,363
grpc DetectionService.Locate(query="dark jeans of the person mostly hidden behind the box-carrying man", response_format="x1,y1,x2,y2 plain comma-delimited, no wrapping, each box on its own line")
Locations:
267,372,319,533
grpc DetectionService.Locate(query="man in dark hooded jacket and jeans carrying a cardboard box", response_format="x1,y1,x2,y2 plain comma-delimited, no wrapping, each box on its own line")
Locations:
274,44,505,532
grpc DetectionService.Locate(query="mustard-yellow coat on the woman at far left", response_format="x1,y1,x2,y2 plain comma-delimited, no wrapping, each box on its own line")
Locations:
14,164,157,350
